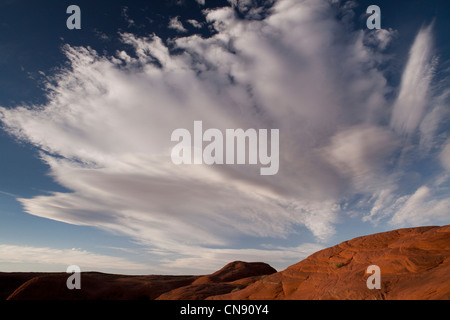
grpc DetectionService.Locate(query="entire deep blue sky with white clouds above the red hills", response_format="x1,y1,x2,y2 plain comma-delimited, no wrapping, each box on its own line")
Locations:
0,0,450,274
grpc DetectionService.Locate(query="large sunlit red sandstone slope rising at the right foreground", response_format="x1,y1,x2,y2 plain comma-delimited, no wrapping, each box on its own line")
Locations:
210,226,450,299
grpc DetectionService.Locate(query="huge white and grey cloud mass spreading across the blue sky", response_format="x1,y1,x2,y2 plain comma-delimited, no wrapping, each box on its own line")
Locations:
0,0,450,272
